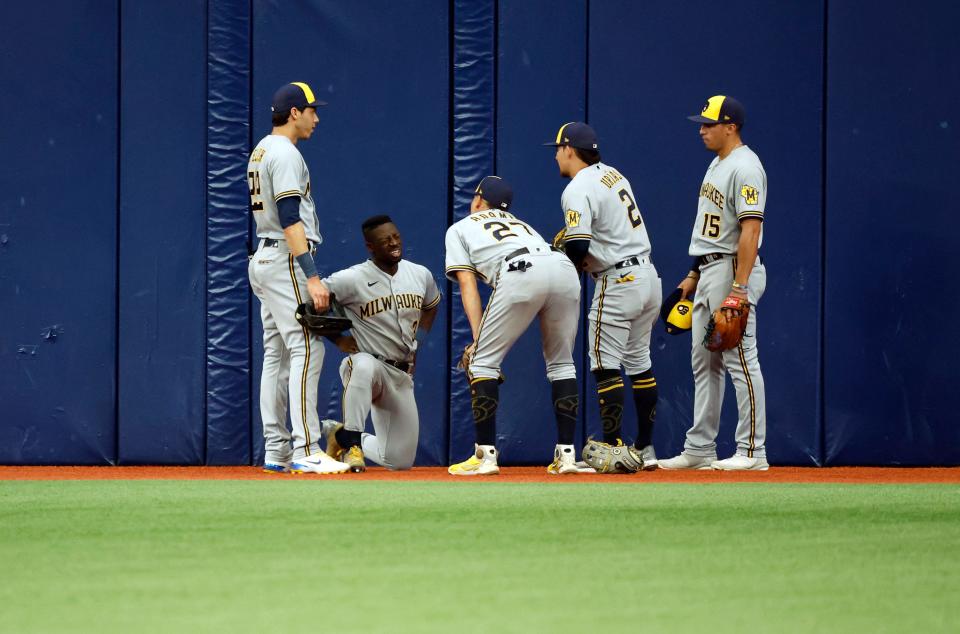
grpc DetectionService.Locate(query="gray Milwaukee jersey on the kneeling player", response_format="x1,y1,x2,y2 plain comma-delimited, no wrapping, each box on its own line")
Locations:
324,260,440,362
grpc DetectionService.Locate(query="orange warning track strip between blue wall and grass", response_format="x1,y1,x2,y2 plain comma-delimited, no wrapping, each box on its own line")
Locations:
0,466,960,484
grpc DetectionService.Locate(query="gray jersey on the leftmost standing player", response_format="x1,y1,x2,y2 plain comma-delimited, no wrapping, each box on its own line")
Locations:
247,134,322,245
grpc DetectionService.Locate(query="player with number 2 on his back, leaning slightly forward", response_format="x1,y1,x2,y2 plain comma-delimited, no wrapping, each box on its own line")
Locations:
545,122,661,470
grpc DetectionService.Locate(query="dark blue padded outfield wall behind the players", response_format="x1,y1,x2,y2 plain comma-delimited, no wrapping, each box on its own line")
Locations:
0,0,960,465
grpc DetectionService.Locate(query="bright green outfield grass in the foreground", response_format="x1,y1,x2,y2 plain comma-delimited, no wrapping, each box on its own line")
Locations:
0,478,960,634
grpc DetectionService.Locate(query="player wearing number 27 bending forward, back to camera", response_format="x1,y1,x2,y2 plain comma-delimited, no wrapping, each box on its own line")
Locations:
446,176,582,476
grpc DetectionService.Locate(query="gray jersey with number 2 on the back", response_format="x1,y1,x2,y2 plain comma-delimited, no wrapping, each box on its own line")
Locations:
561,163,650,273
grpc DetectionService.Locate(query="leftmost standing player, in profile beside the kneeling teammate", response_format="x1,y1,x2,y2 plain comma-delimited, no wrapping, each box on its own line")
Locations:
247,82,348,473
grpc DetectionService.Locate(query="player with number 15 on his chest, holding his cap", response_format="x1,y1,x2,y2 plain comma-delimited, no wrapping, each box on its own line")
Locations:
660,95,769,471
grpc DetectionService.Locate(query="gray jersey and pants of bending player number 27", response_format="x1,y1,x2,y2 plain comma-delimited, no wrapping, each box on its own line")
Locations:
446,210,580,381
